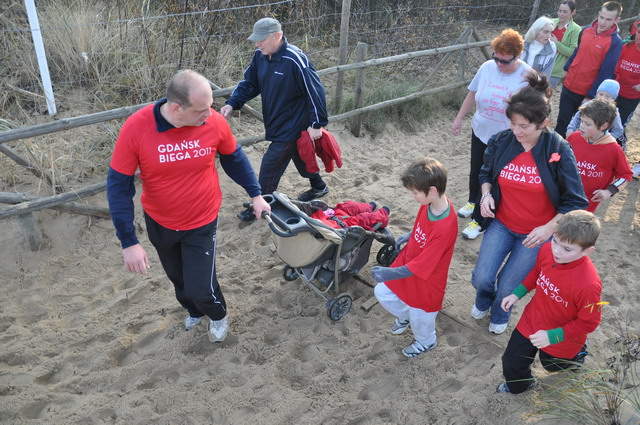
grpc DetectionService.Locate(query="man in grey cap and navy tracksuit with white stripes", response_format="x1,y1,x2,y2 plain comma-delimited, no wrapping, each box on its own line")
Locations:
220,18,329,222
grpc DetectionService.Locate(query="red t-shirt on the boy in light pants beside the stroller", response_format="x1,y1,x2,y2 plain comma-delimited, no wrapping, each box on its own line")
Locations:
385,201,458,313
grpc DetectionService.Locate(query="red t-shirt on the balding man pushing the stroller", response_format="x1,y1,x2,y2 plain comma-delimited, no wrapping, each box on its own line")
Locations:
111,105,236,230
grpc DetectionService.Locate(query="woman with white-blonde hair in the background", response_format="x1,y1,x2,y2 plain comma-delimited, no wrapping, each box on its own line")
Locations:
522,16,556,78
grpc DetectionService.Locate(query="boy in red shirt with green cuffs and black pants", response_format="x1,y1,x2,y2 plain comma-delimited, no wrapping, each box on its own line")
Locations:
496,210,602,394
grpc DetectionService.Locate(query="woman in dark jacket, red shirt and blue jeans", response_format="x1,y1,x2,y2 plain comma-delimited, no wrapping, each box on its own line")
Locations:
471,71,588,334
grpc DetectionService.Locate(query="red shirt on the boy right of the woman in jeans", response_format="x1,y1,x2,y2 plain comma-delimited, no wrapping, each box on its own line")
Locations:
567,131,633,212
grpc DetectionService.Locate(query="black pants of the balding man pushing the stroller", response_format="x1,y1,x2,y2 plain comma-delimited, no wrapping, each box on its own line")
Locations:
144,213,227,320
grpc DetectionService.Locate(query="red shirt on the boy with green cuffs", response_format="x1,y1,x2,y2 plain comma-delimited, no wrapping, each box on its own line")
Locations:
516,242,602,359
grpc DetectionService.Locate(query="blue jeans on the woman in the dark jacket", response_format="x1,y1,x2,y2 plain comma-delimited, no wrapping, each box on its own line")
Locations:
471,219,540,325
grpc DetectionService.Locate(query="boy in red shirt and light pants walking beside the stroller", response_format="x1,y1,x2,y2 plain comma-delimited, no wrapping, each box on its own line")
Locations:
371,158,458,357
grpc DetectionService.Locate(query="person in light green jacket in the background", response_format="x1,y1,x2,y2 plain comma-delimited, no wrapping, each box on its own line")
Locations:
549,0,582,88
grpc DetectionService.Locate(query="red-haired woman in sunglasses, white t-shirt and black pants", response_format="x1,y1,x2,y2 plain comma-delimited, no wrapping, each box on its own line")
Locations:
451,28,531,239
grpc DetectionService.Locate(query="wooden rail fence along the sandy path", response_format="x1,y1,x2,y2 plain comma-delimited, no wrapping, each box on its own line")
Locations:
0,27,490,251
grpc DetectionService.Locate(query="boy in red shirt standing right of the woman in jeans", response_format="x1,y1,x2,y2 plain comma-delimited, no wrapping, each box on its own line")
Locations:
567,99,633,212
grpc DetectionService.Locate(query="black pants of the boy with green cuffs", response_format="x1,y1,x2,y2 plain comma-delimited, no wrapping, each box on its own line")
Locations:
502,329,575,394
